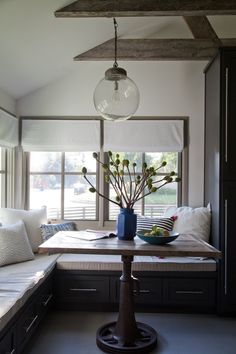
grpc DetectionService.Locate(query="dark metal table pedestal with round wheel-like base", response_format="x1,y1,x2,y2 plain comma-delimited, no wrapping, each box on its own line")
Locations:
97,256,157,354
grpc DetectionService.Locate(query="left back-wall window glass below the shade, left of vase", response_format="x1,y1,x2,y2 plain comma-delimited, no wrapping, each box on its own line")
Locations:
29,152,97,220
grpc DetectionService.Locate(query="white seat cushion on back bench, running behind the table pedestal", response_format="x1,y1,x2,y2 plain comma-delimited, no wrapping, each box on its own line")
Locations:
57,253,216,272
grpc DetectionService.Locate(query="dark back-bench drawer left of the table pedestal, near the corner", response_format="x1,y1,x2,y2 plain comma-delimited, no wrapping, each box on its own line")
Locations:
57,275,109,303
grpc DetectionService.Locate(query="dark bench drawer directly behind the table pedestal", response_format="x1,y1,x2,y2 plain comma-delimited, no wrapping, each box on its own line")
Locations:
111,277,162,306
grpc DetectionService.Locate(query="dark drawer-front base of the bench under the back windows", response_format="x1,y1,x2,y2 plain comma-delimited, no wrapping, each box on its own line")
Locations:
55,270,217,312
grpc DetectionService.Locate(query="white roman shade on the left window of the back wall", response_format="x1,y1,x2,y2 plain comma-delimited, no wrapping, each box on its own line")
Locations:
22,119,100,151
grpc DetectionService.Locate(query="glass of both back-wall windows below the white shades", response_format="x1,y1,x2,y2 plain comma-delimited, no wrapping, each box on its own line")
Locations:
29,152,181,220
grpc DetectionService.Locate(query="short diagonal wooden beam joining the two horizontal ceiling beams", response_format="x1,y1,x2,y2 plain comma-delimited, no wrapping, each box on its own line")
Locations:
184,16,221,44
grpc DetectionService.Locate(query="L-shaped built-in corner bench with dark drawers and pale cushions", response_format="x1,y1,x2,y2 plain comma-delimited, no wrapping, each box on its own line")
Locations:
0,254,217,354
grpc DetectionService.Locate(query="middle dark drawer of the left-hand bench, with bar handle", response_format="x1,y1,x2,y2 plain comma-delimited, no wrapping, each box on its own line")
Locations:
17,303,39,346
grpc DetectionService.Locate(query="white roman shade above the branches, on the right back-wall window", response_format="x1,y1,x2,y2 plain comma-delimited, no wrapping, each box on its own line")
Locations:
104,120,184,152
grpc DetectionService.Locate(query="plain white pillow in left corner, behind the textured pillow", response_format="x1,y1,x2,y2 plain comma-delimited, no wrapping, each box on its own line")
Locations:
0,207,47,252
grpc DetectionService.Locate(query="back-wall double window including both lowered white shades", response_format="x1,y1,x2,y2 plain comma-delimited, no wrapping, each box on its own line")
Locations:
25,119,186,223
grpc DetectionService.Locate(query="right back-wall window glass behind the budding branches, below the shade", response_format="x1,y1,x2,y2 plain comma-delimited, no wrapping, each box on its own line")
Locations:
109,152,181,220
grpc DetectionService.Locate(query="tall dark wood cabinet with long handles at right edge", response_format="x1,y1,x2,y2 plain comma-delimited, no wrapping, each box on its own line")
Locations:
204,48,236,313
